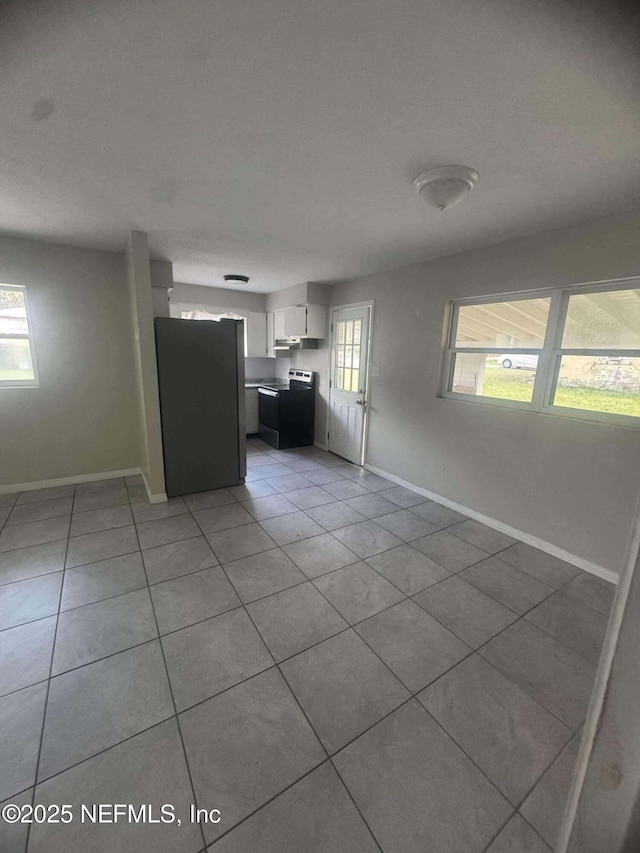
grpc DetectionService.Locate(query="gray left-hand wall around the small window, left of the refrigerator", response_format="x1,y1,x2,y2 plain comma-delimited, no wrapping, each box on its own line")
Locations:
0,237,140,485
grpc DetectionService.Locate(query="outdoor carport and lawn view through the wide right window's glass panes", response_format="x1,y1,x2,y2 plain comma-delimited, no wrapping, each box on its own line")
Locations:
450,289,640,417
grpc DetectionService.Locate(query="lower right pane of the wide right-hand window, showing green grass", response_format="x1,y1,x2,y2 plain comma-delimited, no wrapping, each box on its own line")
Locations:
553,355,640,417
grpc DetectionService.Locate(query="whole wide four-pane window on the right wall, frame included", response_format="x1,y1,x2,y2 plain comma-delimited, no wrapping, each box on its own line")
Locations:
443,281,640,426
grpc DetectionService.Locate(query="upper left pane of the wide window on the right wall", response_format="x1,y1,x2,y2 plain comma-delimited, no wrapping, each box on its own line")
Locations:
455,297,551,349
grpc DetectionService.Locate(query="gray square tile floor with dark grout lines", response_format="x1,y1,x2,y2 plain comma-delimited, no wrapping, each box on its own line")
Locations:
0,440,613,853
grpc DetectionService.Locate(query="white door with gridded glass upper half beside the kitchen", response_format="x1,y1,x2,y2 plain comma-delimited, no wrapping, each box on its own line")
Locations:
329,305,371,465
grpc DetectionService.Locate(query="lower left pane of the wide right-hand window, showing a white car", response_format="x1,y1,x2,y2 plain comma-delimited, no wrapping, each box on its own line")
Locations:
451,352,537,403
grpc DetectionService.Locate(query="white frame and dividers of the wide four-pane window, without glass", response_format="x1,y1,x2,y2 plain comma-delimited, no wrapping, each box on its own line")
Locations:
440,278,640,429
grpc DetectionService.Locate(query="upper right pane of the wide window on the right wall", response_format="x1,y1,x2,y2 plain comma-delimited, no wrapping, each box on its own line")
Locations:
562,290,640,349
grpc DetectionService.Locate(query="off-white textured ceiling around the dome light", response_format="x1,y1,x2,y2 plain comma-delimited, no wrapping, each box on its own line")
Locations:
0,0,640,292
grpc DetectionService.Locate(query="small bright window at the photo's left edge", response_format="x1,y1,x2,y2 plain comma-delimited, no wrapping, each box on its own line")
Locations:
0,284,38,388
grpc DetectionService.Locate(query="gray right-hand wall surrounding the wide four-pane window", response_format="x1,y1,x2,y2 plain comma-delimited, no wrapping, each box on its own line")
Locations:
328,214,640,571
